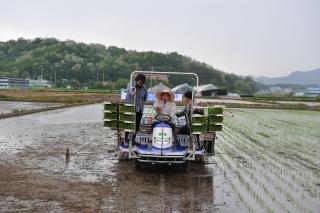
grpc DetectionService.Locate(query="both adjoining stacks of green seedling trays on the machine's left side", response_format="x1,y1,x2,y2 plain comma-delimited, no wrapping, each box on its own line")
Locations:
103,102,135,132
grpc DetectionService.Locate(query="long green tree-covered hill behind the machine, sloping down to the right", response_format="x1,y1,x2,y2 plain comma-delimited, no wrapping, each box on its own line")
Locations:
0,38,255,93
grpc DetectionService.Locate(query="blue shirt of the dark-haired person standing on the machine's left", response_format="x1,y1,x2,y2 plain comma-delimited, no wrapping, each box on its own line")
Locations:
126,85,148,112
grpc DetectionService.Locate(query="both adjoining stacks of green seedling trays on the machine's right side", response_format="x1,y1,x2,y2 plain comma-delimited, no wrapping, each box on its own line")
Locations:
192,106,224,134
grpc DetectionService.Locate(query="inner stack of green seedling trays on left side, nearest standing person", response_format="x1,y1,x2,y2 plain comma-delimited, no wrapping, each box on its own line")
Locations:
119,104,135,132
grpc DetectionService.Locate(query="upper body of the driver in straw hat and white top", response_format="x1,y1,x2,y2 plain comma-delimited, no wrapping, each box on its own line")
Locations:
154,89,177,117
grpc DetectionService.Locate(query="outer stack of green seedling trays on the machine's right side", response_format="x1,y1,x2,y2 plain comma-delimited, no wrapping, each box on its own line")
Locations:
208,106,224,132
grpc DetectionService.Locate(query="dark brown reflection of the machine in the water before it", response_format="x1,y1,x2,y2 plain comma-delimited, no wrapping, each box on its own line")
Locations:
105,162,214,212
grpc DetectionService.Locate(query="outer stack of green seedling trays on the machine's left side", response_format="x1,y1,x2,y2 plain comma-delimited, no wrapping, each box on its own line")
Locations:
103,102,119,130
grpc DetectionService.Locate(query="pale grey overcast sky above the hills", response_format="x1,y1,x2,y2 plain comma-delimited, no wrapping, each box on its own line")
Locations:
0,0,320,76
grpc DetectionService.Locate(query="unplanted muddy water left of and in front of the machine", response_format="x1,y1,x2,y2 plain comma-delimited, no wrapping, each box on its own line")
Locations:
0,105,246,212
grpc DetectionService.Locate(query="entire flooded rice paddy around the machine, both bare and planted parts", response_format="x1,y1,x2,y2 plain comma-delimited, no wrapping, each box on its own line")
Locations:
0,104,320,212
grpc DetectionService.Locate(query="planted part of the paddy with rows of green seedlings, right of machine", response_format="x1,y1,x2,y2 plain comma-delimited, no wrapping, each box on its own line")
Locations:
215,109,320,212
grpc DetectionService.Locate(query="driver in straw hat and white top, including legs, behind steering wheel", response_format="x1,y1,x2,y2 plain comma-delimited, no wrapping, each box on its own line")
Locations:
151,89,179,146
